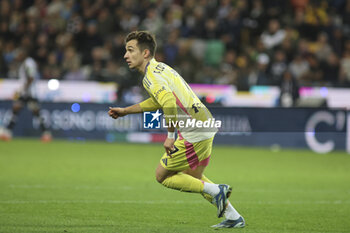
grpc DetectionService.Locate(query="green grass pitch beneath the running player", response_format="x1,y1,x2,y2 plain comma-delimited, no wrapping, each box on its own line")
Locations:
0,139,350,233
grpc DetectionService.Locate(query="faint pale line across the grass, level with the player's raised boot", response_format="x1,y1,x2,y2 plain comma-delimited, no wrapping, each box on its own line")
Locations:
0,200,350,205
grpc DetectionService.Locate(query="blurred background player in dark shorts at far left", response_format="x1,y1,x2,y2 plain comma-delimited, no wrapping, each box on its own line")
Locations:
0,48,52,142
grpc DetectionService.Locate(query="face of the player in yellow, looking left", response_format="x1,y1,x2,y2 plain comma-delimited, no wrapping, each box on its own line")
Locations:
124,40,144,69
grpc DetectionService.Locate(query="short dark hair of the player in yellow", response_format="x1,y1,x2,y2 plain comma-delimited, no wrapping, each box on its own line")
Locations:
125,31,157,56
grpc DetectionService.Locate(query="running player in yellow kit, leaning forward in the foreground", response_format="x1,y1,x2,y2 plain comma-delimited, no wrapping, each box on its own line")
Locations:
108,31,245,228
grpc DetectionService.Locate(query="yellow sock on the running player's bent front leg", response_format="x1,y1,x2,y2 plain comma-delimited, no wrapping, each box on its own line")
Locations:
162,172,204,193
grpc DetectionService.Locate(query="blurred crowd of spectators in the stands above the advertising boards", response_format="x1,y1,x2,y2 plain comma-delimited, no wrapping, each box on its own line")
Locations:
0,0,350,90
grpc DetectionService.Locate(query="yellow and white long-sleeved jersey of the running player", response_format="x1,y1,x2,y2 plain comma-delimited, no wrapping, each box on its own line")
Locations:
140,58,221,143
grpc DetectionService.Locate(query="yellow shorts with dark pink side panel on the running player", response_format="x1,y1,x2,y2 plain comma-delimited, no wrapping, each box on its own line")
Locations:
160,137,214,171
